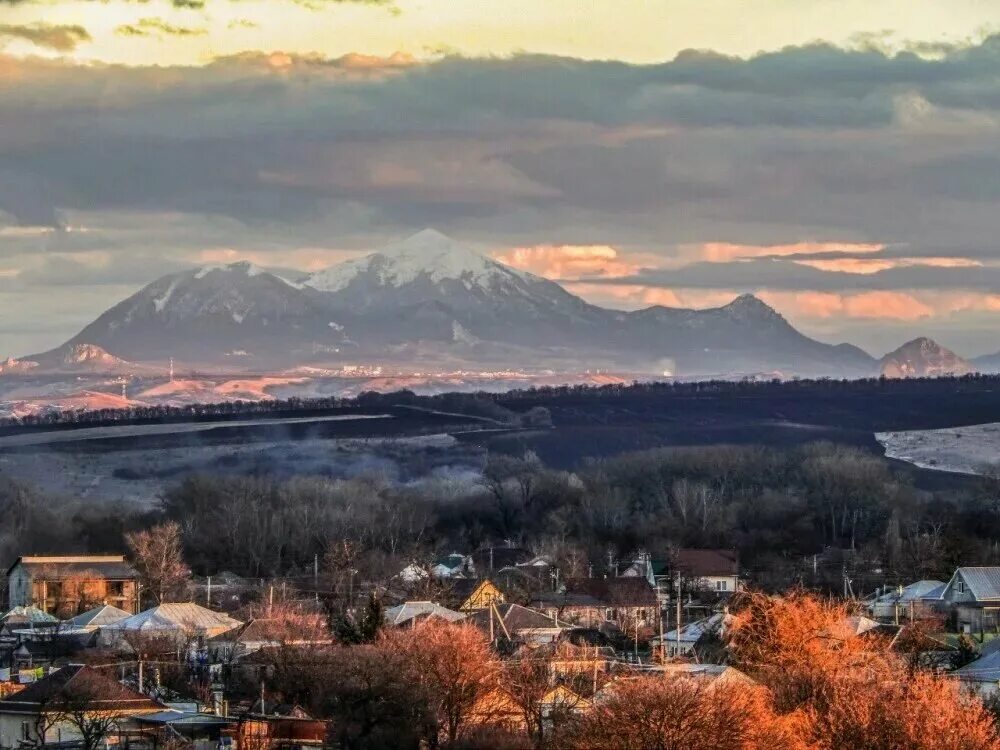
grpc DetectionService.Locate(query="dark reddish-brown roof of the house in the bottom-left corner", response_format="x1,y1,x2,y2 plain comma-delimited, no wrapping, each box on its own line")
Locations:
0,664,166,714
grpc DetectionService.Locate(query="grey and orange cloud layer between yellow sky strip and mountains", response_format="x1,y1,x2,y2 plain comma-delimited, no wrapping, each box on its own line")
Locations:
0,39,1000,354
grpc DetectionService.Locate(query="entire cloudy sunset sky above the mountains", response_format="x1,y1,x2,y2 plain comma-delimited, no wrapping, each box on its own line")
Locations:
0,0,1000,356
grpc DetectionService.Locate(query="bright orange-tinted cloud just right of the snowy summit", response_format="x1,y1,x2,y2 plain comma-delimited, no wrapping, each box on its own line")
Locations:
493,245,661,279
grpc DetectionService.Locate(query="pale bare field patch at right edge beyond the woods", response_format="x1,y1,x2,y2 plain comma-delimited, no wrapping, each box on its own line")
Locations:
875,423,1000,474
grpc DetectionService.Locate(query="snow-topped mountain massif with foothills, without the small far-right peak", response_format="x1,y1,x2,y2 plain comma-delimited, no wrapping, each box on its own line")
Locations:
6,230,996,377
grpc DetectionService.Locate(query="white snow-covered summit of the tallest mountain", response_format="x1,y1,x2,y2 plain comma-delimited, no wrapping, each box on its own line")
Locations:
305,229,528,292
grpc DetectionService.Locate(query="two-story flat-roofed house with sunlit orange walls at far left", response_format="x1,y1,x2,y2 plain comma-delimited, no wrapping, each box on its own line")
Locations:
7,555,139,617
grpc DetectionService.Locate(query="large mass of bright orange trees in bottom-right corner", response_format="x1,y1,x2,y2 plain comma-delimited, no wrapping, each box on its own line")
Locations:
726,591,1000,750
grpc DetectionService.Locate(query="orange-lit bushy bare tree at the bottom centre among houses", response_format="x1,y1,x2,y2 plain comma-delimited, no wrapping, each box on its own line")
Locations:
377,619,499,742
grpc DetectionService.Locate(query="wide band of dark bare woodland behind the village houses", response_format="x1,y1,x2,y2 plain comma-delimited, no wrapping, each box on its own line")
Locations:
7,443,1000,591
